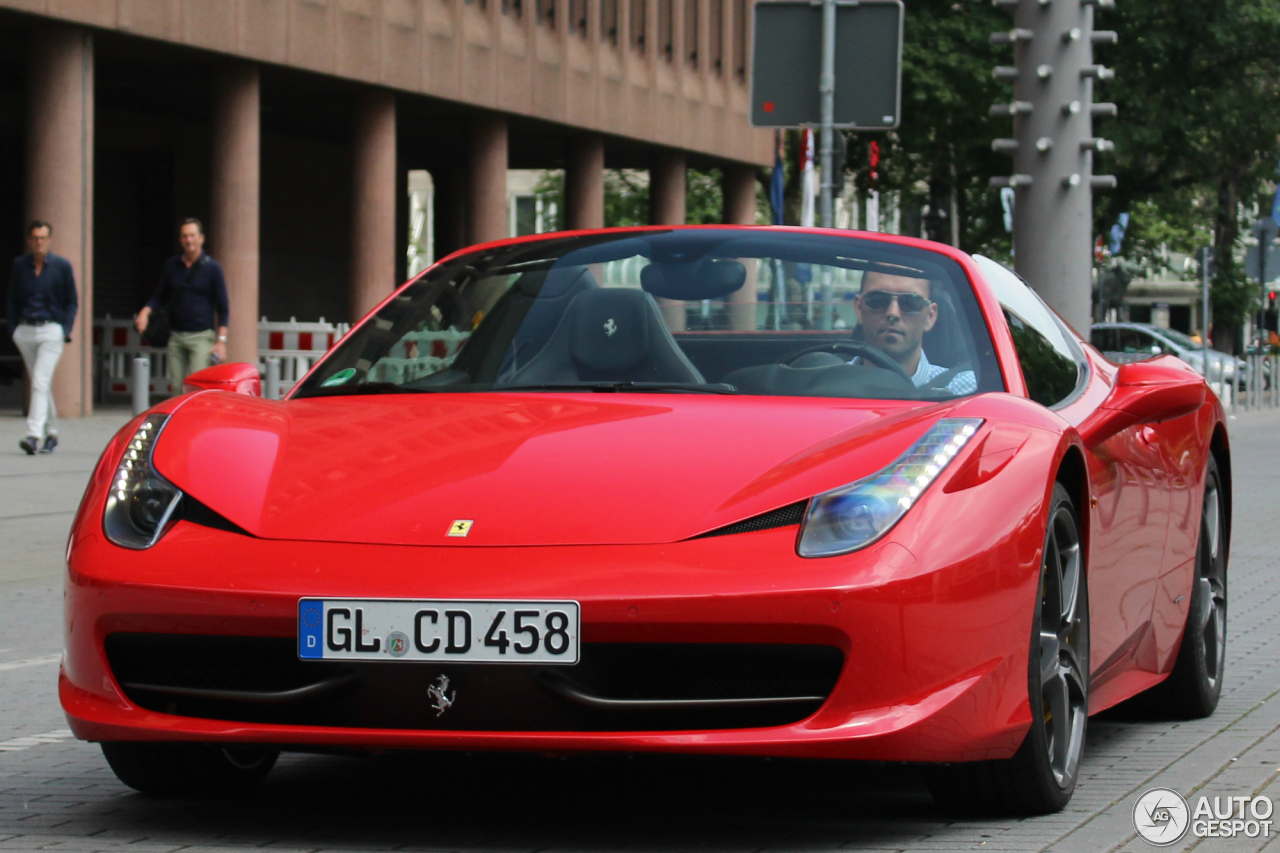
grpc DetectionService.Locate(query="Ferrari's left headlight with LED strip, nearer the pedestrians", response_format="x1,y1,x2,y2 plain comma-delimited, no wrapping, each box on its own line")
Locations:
102,415,182,549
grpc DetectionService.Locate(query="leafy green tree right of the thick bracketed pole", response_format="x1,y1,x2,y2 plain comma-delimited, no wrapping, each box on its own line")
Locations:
1097,0,1280,350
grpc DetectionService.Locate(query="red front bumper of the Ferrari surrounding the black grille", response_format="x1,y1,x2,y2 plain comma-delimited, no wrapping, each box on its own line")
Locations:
60,489,1042,761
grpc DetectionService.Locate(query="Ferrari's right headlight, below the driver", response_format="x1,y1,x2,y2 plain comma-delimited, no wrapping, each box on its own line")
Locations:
797,418,982,557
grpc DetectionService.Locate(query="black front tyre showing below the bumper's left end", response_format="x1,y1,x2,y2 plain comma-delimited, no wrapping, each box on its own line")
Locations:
101,742,280,797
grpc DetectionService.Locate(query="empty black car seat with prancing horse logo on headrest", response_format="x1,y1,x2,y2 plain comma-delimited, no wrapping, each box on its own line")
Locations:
503,287,705,386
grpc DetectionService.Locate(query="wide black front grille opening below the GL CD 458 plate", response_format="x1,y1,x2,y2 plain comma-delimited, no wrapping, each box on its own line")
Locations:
106,634,844,731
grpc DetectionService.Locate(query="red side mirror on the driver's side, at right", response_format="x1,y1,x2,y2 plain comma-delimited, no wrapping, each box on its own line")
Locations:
1079,356,1208,447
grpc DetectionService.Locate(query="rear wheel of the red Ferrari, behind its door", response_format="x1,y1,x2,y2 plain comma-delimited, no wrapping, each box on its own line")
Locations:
1151,457,1230,720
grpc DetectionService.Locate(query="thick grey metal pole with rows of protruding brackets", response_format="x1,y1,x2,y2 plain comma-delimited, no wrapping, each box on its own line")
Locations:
989,0,1116,332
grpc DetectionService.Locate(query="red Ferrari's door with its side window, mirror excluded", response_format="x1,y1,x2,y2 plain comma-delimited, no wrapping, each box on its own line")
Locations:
979,259,1169,676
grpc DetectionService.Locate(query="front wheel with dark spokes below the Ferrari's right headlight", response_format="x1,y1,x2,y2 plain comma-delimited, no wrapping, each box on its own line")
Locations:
928,483,1089,815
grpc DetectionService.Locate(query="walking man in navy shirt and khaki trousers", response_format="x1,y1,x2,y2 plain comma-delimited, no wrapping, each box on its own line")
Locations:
133,219,229,394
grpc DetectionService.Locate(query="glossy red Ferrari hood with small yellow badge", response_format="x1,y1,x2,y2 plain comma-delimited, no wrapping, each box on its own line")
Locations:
155,392,962,546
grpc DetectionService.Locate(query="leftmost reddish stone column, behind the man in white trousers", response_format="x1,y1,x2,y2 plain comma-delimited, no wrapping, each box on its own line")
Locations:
23,27,93,418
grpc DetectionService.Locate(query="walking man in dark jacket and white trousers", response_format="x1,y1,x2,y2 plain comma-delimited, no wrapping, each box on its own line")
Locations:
9,219,79,456
